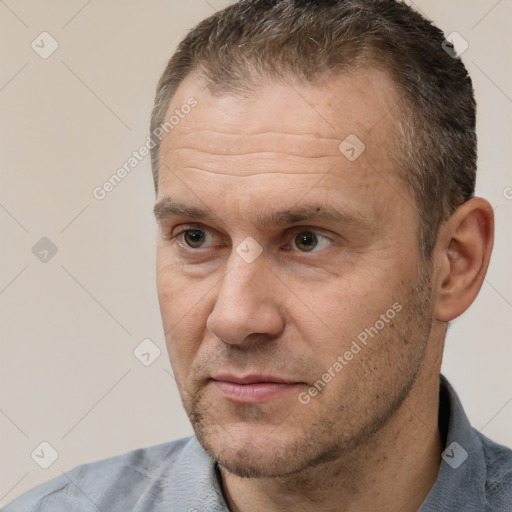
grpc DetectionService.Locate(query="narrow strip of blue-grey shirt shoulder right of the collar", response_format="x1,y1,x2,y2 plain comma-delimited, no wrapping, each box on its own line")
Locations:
476,432,512,511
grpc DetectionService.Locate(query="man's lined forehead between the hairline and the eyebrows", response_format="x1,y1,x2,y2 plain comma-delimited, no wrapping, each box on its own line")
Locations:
155,69,410,228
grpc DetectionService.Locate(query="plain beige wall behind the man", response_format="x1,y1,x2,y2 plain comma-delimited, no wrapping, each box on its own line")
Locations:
0,0,512,503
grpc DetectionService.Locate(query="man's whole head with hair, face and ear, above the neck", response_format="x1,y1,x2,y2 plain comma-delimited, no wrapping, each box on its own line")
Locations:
151,0,492,476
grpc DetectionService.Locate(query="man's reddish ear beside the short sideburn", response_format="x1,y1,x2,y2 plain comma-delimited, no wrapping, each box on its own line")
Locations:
435,197,494,322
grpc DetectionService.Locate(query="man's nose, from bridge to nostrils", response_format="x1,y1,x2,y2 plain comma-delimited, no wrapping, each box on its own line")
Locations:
206,252,284,345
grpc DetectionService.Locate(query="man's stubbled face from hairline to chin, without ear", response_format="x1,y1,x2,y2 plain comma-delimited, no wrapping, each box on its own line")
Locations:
157,70,433,476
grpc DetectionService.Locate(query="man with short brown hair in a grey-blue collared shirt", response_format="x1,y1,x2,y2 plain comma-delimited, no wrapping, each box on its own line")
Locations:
6,0,512,512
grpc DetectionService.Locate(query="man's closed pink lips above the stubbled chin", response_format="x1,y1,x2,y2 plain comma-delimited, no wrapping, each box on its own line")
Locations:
210,374,303,404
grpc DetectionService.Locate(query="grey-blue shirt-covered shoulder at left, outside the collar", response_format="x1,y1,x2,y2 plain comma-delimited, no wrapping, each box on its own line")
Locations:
3,437,200,512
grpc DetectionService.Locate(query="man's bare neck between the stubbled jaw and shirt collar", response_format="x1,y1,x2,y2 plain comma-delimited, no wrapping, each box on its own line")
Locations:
220,356,442,512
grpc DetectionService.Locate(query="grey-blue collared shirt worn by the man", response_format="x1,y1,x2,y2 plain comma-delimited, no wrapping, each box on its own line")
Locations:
4,376,512,512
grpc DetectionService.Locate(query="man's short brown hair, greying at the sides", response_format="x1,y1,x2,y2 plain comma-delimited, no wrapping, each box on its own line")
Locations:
151,0,476,257
